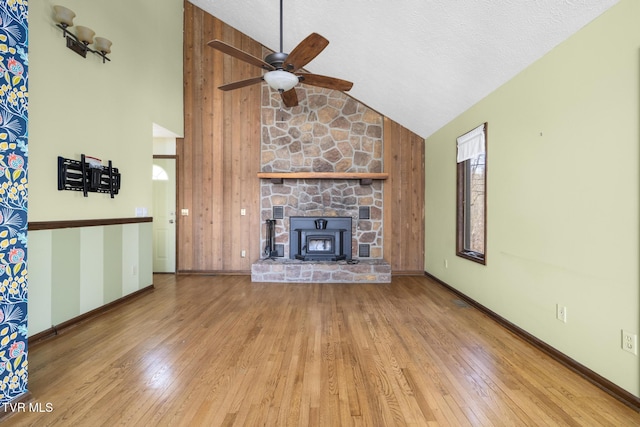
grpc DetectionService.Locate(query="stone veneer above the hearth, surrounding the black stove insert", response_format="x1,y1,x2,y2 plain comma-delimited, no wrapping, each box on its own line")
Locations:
261,84,384,259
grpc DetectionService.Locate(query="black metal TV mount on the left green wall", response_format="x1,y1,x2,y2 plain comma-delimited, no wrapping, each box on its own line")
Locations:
58,154,121,199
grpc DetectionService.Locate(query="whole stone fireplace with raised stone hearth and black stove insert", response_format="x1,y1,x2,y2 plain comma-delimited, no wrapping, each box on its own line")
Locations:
252,79,390,281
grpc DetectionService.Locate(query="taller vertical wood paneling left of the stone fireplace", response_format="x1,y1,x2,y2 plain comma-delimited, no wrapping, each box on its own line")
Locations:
178,1,262,273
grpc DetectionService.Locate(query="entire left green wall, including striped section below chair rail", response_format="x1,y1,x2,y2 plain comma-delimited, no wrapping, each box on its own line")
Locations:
28,0,183,335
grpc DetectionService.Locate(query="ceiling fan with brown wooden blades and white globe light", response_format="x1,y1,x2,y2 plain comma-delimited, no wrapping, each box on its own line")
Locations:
208,0,353,107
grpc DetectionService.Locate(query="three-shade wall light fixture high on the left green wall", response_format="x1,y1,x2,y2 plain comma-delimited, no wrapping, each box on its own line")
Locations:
53,6,111,64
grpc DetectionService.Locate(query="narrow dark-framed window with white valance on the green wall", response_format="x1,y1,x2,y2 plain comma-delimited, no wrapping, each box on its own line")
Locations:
456,123,487,264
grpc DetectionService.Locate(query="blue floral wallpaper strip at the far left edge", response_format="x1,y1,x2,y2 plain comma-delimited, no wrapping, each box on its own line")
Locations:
0,0,29,404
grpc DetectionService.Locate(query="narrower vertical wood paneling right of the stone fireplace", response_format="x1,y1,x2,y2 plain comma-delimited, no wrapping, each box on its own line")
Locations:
384,118,425,274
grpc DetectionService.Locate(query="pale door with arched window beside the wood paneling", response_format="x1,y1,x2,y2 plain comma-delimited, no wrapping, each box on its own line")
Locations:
153,157,176,273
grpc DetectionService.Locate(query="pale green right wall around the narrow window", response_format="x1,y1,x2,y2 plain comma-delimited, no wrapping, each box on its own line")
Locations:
425,0,640,396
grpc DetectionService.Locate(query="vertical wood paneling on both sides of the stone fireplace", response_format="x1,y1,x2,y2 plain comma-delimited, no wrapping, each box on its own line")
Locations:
177,1,424,274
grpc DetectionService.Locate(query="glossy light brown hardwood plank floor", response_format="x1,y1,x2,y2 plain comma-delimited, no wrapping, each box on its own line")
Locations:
4,275,640,427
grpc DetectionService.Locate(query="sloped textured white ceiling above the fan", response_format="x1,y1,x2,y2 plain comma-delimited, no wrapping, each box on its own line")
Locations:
189,0,618,137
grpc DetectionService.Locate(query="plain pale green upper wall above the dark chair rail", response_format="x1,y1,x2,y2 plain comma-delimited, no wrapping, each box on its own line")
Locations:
29,0,183,221
